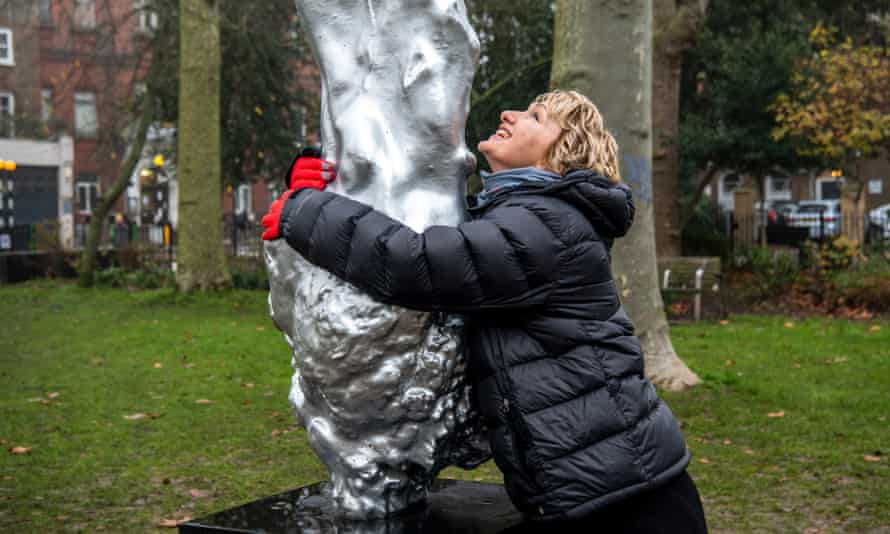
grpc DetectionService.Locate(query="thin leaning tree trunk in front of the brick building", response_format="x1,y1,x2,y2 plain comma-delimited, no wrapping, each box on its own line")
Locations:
78,101,152,287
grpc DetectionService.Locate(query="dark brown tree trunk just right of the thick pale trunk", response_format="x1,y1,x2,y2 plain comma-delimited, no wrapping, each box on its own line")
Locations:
652,0,707,257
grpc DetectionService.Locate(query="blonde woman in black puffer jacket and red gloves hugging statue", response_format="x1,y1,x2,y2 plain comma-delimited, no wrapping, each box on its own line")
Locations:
263,91,706,533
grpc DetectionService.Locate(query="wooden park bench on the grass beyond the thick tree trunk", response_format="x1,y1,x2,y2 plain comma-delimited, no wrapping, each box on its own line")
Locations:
658,256,726,321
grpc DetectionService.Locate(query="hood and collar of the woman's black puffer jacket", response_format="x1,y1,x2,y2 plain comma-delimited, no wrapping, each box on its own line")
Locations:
468,170,635,240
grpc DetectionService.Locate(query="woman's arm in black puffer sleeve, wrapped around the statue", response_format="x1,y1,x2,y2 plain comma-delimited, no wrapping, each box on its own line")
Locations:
279,190,562,311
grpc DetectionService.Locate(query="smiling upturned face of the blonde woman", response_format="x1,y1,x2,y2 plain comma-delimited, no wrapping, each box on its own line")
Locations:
479,103,562,172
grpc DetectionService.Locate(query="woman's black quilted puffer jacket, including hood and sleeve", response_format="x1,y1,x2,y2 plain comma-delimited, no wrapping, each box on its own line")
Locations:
280,171,689,519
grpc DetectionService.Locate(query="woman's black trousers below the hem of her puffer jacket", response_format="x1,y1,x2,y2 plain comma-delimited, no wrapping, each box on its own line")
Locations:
502,471,708,534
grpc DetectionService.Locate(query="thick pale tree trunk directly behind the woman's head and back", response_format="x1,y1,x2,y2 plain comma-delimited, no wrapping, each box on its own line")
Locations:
551,0,699,390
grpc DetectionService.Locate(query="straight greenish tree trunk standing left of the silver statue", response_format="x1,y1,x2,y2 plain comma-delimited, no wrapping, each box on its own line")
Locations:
176,0,230,292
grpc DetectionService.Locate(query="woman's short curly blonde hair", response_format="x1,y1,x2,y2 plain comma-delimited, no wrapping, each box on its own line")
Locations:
534,91,621,183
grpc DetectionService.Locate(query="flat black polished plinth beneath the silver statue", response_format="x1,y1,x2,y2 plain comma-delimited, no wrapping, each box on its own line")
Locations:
179,479,522,534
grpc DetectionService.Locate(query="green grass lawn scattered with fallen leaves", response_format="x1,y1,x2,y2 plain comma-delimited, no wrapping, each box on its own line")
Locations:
0,282,890,534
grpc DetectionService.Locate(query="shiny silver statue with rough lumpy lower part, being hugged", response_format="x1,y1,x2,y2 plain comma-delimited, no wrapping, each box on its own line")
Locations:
265,0,489,518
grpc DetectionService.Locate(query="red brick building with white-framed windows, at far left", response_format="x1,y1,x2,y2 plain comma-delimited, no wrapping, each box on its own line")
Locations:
0,0,319,253
